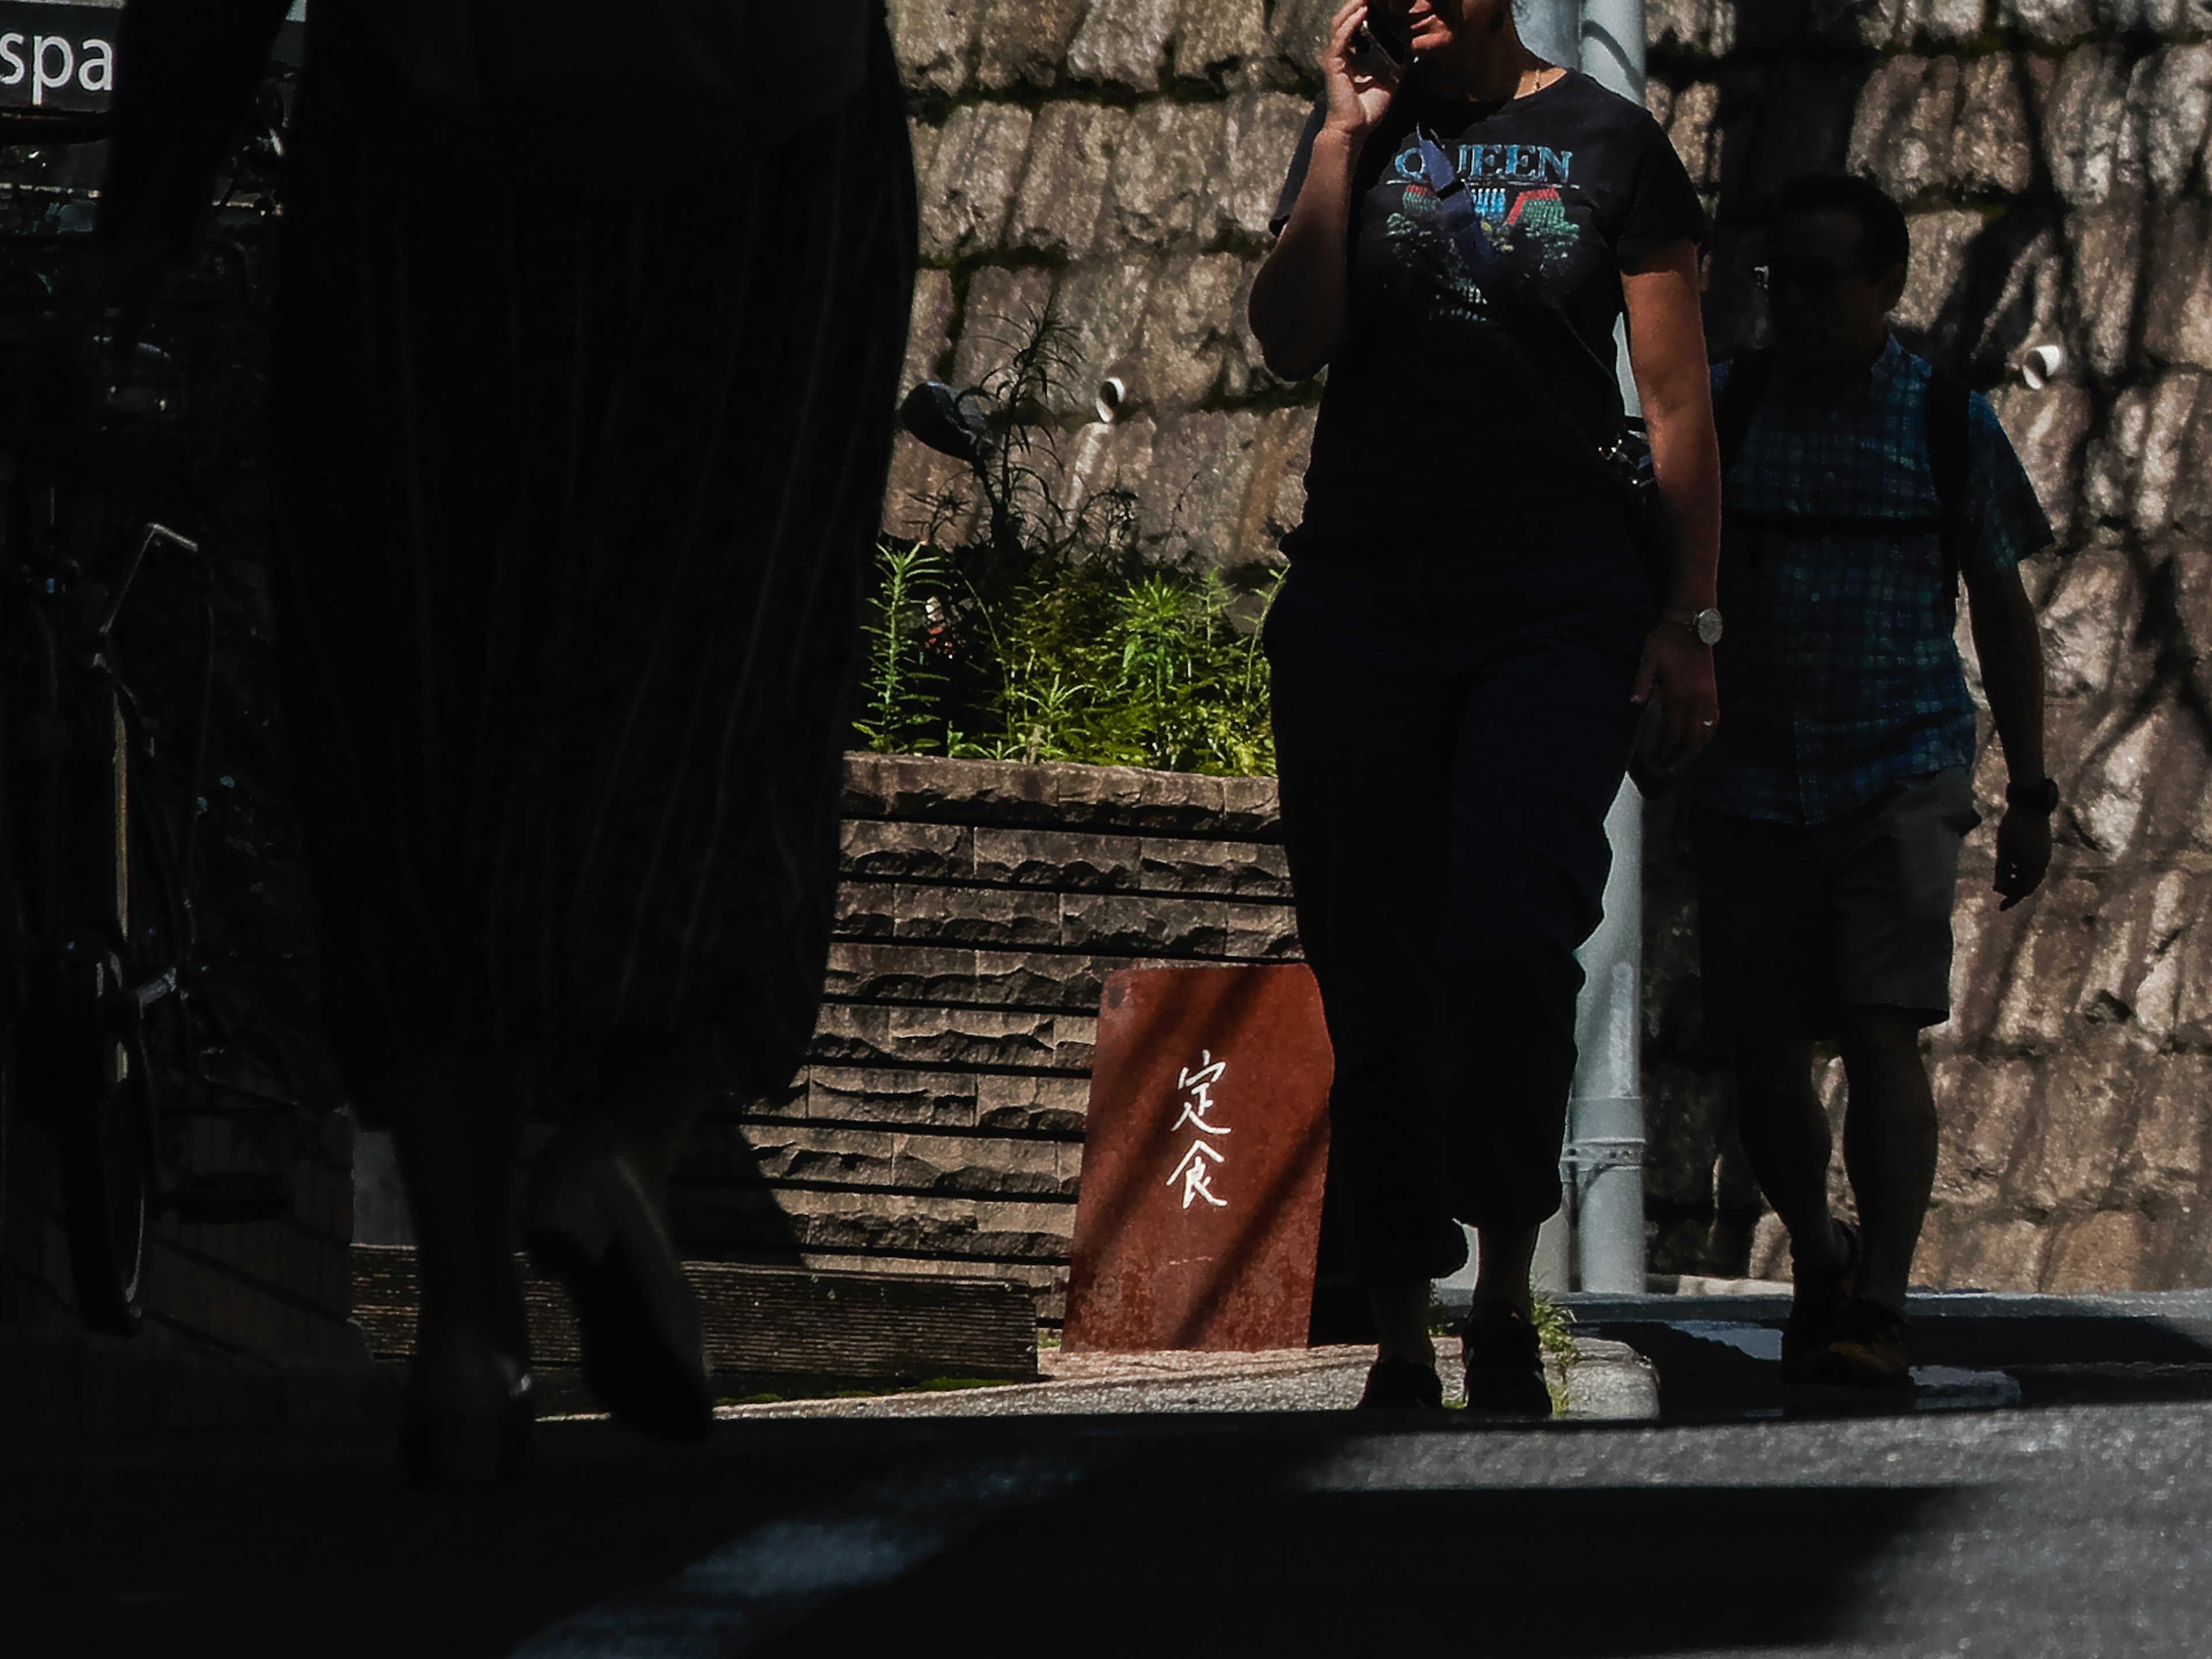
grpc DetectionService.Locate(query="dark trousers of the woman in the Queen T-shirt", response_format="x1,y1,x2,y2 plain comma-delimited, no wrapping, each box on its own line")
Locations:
1267,509,1657,1285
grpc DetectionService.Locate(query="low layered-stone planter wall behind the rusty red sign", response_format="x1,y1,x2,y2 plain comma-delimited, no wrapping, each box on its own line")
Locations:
671,754,1298,1323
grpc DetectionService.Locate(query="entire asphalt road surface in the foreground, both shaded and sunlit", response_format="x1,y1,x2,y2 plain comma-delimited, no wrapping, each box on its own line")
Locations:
0,1404,2212,1659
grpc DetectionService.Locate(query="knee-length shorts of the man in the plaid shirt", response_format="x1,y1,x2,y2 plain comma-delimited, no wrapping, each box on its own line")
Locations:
1696,766,1982,1042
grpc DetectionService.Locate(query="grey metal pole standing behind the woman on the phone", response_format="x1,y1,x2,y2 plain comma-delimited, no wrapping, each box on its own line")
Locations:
1566,0,1643,1294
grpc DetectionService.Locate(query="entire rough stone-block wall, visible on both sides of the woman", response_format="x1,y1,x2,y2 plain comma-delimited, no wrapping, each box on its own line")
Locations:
887,0,2212,1290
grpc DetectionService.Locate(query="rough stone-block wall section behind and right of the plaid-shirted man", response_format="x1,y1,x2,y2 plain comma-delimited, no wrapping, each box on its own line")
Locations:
1648,0,2212,1290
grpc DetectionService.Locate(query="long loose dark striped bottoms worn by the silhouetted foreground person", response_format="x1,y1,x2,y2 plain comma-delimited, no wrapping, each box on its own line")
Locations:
279,42,914,1106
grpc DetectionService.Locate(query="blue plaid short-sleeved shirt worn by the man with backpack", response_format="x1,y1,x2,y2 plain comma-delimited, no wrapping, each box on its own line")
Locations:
1696,339,2053,823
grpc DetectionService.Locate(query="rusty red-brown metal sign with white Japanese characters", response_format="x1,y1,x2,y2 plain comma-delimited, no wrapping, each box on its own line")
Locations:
1062,964,1332,1354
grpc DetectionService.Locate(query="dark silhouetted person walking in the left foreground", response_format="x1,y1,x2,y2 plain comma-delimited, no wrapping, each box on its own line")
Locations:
100,0,914,1482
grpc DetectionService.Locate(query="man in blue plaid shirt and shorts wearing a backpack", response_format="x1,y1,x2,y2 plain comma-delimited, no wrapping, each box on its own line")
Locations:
1696,175,2057,1387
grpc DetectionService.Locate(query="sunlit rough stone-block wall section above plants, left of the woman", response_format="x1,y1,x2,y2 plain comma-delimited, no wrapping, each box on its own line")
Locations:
887,0,1334,564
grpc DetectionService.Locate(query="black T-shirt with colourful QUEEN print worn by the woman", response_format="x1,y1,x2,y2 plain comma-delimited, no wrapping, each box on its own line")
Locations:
1272,71,1706,558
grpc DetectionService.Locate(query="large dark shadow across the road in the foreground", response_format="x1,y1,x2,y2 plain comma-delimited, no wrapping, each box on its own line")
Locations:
13,1414,1953,1659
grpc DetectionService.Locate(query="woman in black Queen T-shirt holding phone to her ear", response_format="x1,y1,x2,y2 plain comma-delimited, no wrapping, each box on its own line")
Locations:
1252,0,1721,1416
